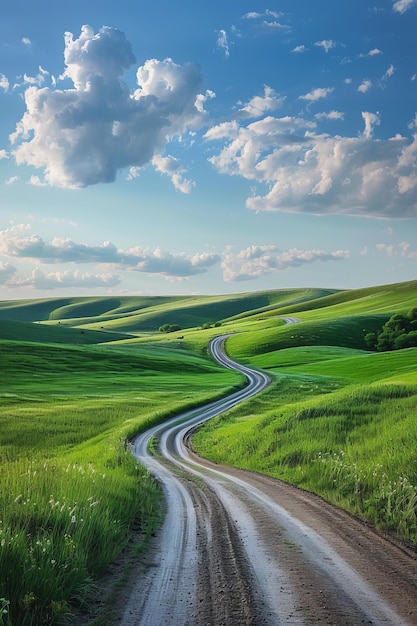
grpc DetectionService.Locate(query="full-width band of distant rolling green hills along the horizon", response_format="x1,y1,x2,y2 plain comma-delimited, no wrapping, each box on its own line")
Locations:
0,281,417,344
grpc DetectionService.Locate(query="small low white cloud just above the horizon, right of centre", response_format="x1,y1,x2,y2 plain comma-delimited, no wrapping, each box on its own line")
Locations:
222,245,350,282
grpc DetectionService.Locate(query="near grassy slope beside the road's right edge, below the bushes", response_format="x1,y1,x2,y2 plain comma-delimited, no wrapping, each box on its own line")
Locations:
193,376,417,545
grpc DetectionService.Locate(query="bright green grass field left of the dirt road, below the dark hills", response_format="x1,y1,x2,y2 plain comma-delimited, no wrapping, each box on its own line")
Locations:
0,341,240,626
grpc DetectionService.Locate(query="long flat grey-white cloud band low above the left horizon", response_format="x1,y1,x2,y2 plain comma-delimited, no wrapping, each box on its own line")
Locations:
0,224,220,278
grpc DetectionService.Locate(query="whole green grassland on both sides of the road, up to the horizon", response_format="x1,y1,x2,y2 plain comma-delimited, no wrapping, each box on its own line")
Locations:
0,281,417,626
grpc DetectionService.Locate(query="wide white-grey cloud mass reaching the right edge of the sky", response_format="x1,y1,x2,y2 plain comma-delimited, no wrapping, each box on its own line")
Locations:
205,112,417,218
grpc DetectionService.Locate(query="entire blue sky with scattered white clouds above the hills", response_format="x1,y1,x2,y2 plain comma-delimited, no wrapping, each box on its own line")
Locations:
0,0,417,300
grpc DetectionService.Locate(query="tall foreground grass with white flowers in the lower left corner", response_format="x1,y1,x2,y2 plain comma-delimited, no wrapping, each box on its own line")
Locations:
0,444,159,626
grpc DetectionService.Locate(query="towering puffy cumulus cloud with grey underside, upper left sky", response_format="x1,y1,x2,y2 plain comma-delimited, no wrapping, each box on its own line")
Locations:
10,26,206,187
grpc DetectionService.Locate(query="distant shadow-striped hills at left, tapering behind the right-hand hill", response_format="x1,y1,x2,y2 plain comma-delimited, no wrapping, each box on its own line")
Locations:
0,289,333,333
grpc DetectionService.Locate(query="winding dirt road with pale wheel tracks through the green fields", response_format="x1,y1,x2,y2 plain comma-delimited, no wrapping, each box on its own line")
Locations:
125,334,417,626
